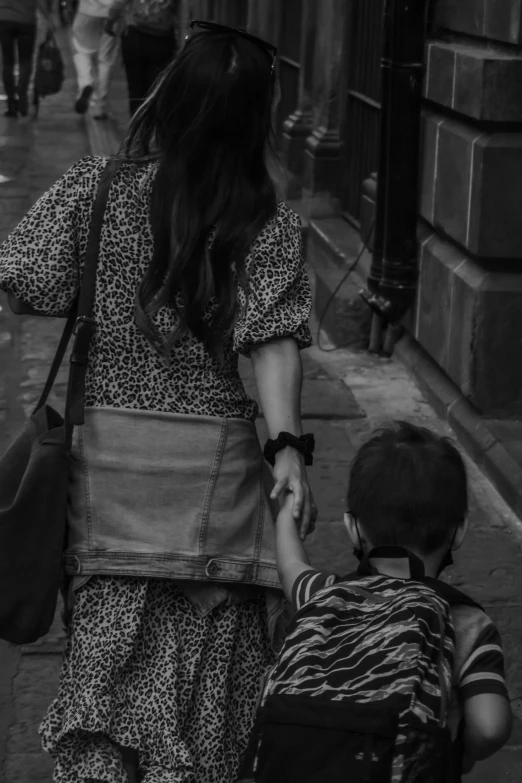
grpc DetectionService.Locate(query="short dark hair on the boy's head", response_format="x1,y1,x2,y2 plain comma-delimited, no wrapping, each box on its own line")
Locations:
348,421,468,555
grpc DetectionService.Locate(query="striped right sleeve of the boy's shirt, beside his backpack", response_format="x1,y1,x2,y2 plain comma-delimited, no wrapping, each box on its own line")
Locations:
457,618,509,701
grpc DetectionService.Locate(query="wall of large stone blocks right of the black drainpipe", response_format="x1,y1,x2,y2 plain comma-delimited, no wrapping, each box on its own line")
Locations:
412,0,522,417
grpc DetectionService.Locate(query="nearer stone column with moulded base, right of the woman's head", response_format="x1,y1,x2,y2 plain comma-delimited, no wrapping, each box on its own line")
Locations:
303,0,349,216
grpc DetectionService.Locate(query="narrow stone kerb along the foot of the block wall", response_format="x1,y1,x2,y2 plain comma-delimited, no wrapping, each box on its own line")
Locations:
395,334,522,535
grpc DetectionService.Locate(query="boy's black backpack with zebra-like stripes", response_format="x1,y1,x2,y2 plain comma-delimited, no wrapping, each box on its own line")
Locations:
244,548,480,783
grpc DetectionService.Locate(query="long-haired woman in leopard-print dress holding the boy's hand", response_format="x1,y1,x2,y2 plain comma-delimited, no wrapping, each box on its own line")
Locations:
0,18,316,783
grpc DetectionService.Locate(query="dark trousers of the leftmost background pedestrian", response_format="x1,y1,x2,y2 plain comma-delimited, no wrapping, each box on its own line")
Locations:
0,22,36,106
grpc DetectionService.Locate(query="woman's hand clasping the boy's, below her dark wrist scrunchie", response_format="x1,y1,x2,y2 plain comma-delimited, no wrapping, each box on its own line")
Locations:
270,446,317,541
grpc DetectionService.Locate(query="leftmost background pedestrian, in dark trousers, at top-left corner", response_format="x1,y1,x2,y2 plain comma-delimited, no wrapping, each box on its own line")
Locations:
0,0,49,117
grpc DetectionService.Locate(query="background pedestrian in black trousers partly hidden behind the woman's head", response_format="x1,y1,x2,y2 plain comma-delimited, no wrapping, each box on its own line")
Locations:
106,0,179,117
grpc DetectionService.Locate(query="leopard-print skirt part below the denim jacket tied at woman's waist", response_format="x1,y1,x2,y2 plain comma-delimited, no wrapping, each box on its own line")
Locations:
40,576,273,783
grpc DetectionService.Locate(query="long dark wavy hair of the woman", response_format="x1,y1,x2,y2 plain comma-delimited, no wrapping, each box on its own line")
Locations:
119,32,277,357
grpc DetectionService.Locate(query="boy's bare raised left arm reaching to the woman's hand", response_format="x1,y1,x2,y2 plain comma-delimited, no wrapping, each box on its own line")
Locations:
276,492,310,601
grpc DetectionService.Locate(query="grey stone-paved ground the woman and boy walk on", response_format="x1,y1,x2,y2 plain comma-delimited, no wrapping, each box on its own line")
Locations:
0,24,522,783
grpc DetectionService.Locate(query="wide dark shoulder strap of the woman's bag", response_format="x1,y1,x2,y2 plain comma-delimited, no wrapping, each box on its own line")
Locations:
65,160,120,450
